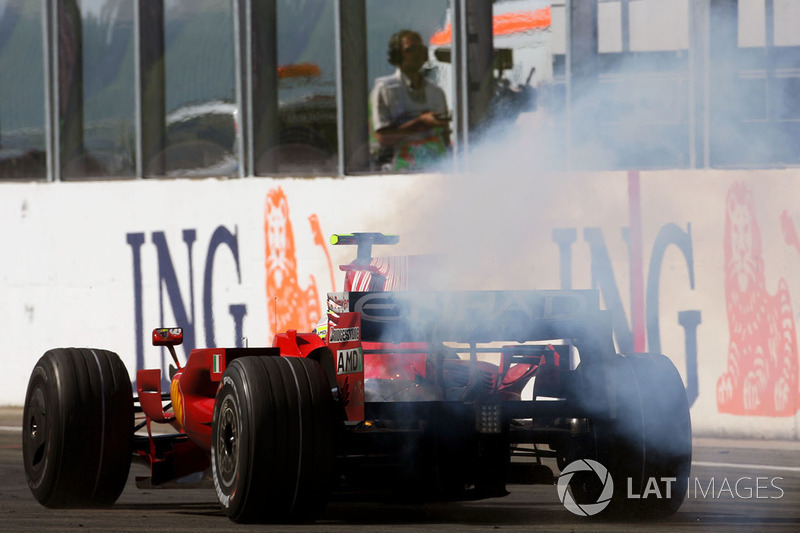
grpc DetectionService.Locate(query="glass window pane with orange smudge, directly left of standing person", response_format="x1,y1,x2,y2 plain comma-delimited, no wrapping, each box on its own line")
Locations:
272,0,338,175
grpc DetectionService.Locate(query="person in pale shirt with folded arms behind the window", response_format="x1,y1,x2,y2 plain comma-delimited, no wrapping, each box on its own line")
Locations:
370,30,450,170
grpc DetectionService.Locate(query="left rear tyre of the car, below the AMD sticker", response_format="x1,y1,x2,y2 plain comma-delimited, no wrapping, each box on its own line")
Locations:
211,356,334,522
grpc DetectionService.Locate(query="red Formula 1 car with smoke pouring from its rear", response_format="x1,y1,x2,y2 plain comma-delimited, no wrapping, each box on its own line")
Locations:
23,233,691,522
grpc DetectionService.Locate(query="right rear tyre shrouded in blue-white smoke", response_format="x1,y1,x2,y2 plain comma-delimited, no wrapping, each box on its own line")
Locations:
571,354,692,519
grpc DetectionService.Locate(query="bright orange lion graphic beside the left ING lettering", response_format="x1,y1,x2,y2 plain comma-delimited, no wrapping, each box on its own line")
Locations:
264,187,330,335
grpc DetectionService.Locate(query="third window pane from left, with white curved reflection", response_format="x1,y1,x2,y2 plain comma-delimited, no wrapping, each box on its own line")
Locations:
164,0,239,176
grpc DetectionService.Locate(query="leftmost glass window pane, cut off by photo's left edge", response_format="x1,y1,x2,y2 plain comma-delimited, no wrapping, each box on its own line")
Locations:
0,0,47,179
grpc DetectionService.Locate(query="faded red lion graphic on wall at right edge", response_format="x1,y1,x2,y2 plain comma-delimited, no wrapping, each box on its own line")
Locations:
717,183,798,416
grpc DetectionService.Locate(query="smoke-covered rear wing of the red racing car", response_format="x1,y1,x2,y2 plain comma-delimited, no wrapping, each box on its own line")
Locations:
328,290,614,354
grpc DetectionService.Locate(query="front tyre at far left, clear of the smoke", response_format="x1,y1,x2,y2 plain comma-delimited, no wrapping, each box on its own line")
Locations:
22,348,134,507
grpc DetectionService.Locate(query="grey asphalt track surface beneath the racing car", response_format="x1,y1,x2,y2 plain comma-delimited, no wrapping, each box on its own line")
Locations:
0,409,800,533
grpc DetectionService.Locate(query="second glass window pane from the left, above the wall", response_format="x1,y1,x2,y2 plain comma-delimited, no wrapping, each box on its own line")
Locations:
60,0,136,179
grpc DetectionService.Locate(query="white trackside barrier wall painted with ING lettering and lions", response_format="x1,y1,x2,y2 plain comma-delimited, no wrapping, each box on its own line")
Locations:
0,170,800,439
